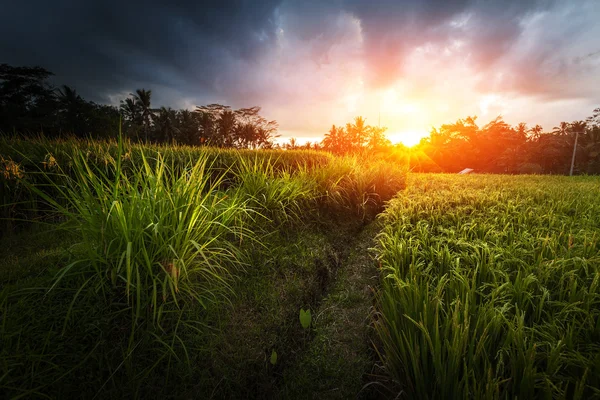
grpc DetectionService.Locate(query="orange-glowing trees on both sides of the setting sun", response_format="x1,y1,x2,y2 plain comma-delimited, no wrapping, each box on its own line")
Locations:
284,112,600,174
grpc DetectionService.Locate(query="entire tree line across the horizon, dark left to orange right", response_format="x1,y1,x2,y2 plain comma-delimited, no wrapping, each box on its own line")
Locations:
0,64,600,174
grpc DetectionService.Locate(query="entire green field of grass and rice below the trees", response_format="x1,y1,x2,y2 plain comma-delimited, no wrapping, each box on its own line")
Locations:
0,139,600,399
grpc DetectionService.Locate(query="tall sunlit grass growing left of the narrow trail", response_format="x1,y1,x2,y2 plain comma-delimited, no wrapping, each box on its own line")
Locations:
0,135,406,397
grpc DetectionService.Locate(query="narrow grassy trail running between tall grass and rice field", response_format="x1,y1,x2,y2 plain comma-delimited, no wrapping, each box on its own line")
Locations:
281,221,380,399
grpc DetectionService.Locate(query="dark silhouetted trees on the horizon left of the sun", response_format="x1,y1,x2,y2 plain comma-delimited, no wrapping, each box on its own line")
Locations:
0,64,279,148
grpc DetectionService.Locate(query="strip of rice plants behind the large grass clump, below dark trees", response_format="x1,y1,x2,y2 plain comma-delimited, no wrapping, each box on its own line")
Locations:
0,136,333,228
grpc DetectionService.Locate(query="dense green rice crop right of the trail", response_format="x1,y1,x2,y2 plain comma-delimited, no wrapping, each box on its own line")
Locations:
375,175,600,399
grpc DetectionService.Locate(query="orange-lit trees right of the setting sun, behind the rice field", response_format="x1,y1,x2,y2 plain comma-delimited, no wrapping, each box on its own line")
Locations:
414,113,600,174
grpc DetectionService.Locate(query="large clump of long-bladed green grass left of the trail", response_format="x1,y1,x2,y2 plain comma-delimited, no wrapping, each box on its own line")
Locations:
32,139,251,324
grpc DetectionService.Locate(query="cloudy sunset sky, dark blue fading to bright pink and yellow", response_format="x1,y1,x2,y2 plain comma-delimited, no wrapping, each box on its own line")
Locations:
0,0,600,144
